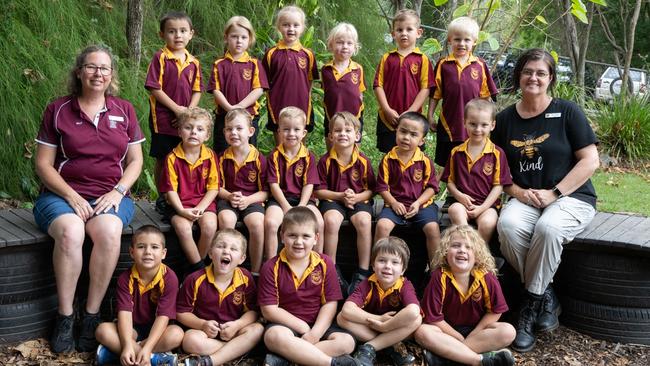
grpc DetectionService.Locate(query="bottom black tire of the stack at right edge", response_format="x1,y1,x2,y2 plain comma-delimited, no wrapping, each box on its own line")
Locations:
560,296,650,345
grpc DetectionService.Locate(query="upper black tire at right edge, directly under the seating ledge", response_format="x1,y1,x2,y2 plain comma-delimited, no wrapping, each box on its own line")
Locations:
555,250,650,308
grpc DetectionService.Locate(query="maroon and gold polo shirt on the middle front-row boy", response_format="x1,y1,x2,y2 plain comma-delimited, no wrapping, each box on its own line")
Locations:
257,249,343,326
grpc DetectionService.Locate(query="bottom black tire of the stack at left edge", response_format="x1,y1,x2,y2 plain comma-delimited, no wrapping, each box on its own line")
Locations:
0,295,57,343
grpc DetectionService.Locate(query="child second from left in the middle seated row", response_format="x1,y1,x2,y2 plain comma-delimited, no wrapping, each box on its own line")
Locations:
217,108,269,276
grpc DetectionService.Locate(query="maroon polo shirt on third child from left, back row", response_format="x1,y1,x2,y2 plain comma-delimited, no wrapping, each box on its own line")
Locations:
262,41,318,124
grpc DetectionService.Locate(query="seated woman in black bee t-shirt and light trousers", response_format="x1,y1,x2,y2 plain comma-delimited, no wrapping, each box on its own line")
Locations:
492,49,598,352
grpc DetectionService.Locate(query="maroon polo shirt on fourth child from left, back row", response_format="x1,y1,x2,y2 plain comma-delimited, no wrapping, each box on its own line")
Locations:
321,60,366,120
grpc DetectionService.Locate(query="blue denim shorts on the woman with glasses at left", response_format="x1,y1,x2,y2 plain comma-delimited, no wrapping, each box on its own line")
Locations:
33,191,135,233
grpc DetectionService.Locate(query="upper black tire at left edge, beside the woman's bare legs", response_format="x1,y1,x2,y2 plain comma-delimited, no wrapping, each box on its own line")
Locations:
0,244,56,304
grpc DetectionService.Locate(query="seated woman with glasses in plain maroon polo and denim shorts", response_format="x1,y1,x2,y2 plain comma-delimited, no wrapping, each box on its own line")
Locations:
34,46,144,353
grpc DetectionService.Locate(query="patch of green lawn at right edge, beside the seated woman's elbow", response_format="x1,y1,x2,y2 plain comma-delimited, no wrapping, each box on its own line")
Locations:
592,169,650,216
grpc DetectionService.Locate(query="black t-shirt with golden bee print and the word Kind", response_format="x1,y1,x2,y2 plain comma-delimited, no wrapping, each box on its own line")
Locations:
491,99,598,207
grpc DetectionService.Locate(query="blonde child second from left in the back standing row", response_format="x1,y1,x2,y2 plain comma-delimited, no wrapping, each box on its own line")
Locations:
208,16,269,154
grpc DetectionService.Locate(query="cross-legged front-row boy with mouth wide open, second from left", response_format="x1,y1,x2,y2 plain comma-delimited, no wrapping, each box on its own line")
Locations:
177,229,264,366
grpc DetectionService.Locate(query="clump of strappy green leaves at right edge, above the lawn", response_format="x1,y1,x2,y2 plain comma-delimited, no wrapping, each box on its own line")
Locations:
596,97,650,161
